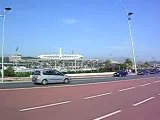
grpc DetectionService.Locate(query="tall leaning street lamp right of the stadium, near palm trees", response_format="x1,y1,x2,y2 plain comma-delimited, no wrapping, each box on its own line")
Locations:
119,0,137,73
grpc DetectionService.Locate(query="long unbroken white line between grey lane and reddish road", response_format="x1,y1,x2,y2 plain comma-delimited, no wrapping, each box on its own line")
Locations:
0,77,157,91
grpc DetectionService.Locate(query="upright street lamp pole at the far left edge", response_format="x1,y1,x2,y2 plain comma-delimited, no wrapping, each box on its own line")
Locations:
0,7,11,82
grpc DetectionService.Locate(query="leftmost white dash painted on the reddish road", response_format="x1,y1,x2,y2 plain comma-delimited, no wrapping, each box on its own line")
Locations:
19,101,71,112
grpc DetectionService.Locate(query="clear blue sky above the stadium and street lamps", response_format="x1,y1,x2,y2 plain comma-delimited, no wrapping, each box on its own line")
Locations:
0,0,160,60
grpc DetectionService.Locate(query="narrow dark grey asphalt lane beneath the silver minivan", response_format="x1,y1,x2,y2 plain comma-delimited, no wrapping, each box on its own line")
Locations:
0,74,160,89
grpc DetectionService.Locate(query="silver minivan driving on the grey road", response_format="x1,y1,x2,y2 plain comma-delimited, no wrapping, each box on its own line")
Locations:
32,70,71,85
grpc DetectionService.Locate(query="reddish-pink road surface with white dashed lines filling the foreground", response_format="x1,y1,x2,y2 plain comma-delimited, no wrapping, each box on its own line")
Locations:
0,76,160,120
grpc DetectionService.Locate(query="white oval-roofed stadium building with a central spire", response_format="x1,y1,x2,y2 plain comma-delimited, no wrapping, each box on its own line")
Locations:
38,48,84,71
